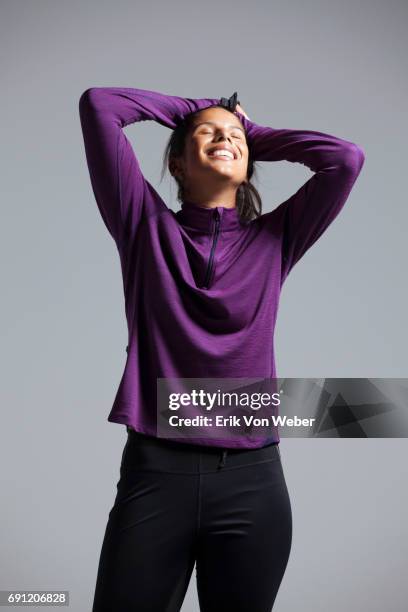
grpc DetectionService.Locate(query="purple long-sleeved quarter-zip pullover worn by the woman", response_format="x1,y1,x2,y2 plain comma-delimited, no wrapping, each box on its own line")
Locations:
79,87,364,448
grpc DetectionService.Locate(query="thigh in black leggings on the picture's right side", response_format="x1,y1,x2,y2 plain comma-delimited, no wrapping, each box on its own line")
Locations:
196,458,292,612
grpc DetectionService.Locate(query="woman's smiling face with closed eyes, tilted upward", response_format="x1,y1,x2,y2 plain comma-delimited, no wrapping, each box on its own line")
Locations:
169,107,248,197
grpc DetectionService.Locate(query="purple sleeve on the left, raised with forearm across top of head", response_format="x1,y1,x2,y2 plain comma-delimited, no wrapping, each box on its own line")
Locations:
79,87,219,251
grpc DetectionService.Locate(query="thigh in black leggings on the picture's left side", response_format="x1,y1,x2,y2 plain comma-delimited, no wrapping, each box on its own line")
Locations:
92,468,197,612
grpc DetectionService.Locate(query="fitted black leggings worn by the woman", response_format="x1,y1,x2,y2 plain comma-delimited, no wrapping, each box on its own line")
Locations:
92,428,292,612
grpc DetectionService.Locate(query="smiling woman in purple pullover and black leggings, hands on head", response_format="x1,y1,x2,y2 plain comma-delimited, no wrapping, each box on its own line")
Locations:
79,87,364,612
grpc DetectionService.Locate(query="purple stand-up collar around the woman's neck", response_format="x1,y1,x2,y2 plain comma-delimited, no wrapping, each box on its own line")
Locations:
176,200,242,233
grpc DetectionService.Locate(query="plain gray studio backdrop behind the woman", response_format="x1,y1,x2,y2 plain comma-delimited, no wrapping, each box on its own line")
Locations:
0,0,408,612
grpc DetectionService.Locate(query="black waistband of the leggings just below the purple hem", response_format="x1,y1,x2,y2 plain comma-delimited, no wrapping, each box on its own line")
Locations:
121,428,280,474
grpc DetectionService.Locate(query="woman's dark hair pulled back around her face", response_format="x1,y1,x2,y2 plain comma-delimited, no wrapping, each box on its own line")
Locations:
160,104,262,222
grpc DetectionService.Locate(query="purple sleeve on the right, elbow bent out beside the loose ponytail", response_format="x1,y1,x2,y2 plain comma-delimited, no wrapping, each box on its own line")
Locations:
234,113,365,284
